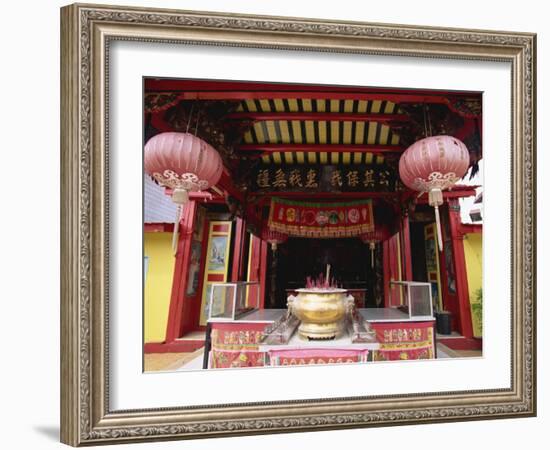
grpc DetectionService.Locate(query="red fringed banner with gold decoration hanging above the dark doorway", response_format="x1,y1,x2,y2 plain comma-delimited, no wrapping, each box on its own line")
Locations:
268,198,374,238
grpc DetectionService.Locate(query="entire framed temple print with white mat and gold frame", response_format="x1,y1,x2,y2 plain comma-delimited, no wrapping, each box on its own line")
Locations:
61,5,536,446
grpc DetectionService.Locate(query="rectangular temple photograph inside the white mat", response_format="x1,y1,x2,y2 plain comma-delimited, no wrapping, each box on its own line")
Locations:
143,78,483,372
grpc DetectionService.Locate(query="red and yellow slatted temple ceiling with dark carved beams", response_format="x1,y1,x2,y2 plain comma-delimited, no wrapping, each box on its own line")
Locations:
144,78,482,218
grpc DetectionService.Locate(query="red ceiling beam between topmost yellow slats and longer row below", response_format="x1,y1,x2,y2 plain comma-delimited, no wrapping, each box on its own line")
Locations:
228,112,410,123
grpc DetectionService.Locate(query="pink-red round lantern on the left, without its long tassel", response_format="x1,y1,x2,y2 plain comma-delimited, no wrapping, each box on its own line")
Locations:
144,132,223,204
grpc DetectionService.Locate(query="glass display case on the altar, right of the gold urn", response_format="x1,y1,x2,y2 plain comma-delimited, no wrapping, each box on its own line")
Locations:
390,281,433,320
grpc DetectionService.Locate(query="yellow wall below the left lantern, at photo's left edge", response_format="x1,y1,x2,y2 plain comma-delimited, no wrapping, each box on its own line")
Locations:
143,233,175,343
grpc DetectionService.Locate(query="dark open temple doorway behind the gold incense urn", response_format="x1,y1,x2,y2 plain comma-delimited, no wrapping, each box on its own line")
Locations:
266,238,383,308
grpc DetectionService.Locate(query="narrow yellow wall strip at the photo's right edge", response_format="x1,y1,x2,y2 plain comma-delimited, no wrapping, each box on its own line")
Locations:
464,233,483,337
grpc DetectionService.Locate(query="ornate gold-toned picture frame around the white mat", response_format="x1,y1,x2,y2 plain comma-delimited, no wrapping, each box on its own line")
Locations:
61,5,536,446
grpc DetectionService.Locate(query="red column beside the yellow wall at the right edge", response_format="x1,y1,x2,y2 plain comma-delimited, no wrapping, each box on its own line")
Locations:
449,199,473,338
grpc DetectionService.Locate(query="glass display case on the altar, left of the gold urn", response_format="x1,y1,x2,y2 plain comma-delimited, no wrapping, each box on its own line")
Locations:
208,281,260,321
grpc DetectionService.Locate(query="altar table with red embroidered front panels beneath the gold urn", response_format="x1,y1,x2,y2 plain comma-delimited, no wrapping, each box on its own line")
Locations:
203,308,435,369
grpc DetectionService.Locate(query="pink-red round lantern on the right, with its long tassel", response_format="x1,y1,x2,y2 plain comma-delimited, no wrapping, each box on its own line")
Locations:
399,136,470,250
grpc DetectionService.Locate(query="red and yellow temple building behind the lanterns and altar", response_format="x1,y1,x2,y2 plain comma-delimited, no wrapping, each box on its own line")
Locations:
144,78,482,362
